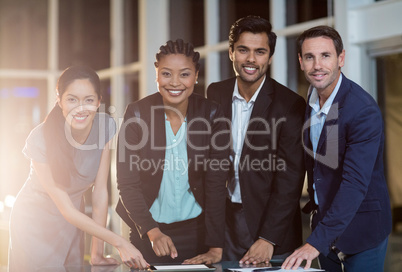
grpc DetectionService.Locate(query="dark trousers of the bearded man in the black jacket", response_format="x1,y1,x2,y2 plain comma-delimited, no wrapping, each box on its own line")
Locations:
222,199,292,261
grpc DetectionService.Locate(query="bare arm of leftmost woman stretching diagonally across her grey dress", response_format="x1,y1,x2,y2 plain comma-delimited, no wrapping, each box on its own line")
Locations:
33,143,148,268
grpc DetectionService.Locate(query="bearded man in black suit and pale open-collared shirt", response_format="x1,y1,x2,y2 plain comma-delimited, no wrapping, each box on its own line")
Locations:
207,16,305,264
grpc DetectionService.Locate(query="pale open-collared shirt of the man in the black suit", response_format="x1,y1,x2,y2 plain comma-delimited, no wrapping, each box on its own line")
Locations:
228,77,265,203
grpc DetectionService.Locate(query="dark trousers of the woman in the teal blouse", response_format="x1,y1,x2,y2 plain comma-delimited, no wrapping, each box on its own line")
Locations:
130,215,209,264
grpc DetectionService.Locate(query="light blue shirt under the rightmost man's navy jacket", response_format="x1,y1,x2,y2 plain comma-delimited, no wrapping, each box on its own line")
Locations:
309,74,342,205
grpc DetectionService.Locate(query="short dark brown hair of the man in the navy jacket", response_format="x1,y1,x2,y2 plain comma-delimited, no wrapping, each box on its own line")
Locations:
296,25,343,56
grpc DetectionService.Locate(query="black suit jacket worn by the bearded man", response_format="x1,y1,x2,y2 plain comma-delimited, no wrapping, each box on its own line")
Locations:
207,77,306,254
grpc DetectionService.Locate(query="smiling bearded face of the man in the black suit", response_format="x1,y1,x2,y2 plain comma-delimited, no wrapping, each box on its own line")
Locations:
229,32,272,85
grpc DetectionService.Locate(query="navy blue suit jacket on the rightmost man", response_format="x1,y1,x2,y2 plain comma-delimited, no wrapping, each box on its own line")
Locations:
303,75,391,255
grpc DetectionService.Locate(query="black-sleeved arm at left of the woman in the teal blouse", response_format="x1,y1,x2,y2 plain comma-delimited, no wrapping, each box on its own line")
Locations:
116,103,159,236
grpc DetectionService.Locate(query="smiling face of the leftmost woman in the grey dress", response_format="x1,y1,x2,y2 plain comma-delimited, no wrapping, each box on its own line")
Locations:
58,79,100,131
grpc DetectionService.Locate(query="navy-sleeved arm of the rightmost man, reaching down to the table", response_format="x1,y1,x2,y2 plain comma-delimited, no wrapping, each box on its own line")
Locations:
307,105,383,255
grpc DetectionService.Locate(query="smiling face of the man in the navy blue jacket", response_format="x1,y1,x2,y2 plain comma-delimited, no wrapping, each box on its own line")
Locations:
299,37,345,97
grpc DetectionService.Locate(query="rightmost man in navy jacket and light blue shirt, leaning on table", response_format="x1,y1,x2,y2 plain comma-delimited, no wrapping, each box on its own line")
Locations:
283,26,391,272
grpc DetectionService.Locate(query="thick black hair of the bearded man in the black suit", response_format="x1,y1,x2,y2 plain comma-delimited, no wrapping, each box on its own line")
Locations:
229,15,276,57
